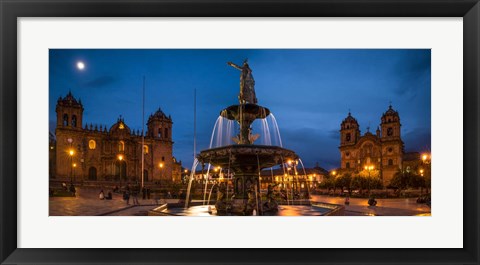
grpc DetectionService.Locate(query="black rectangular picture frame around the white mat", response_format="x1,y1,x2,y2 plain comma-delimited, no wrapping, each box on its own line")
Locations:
0,0,480,264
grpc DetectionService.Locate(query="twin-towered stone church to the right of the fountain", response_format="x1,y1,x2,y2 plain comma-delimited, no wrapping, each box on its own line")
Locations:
339,105,404,185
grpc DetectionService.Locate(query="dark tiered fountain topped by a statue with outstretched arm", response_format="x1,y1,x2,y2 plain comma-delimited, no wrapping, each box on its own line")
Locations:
197,60,298,215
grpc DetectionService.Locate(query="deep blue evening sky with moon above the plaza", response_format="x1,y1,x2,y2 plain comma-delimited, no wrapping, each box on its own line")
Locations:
49,49,431,169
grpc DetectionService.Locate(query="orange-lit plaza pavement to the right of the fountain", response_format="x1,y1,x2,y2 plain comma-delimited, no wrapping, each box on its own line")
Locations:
312,195,431,216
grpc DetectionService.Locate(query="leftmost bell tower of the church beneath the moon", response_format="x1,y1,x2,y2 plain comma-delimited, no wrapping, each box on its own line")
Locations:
55,92,83,130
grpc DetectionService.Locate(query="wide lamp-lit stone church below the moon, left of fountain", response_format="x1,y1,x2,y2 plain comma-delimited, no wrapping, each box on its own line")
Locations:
50,92,181,183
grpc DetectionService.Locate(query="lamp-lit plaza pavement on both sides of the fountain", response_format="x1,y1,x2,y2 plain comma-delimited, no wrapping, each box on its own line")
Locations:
49,187,431,216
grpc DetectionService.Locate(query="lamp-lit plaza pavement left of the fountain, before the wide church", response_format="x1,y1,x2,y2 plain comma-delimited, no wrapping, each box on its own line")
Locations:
49,187,162,216
